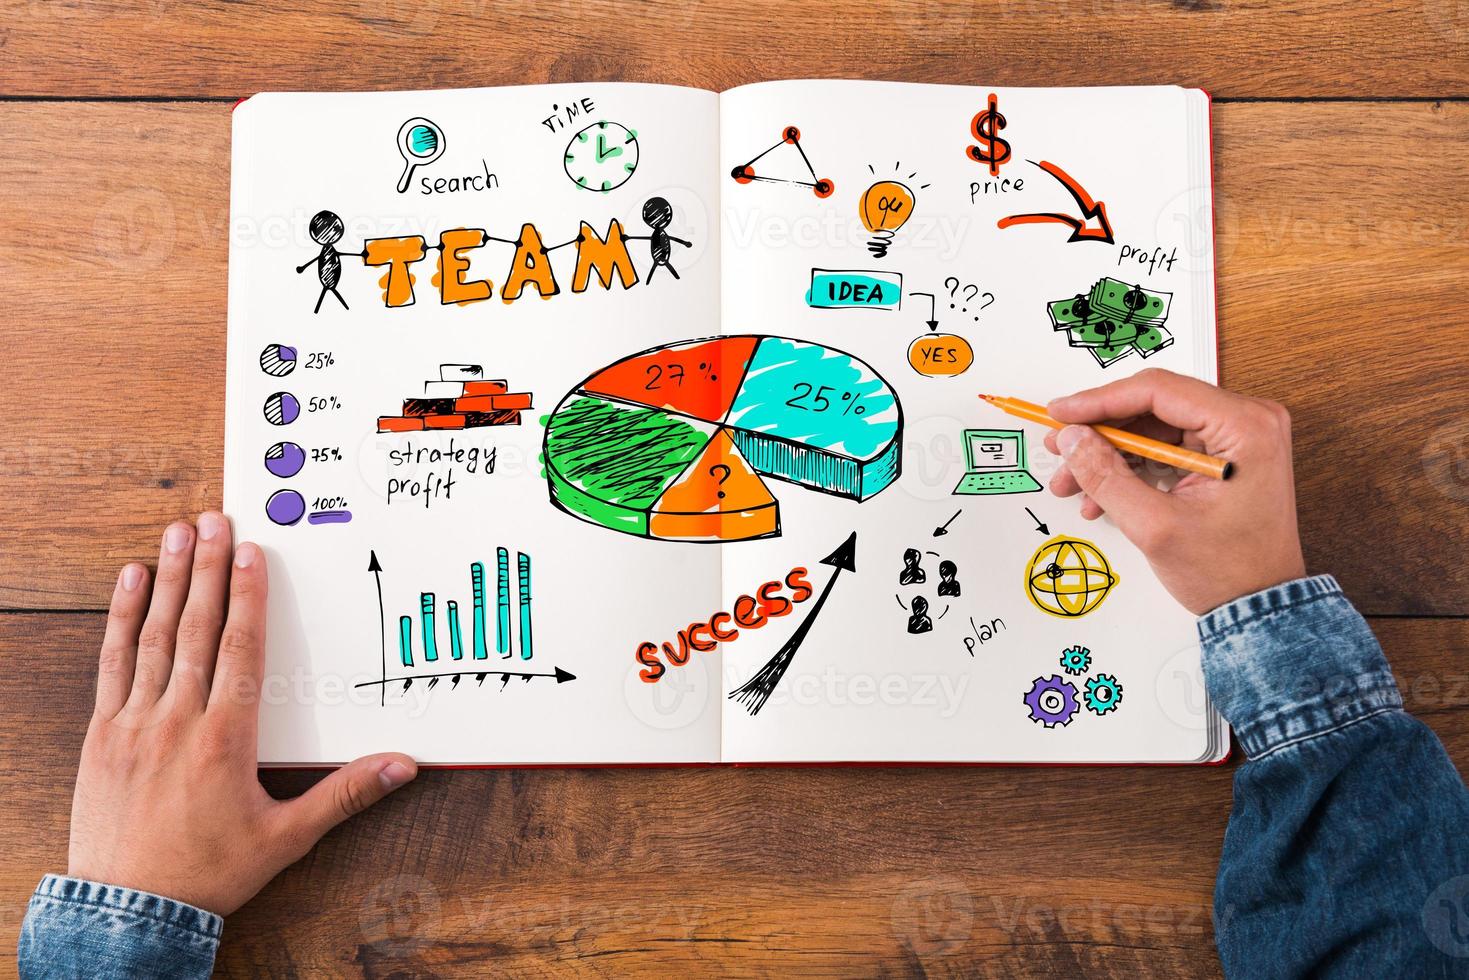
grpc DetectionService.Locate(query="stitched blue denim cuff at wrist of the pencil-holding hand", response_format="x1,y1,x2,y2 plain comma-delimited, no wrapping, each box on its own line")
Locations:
1199,574,1403,758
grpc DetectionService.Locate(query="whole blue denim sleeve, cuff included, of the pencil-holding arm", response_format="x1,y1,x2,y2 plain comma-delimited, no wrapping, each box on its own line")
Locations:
1199,576,1469,977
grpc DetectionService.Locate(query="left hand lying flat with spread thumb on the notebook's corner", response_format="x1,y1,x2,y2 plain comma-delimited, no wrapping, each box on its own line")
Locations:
68,513,417,915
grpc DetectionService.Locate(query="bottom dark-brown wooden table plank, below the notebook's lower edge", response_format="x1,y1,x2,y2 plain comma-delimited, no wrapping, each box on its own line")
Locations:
0,613,1469,977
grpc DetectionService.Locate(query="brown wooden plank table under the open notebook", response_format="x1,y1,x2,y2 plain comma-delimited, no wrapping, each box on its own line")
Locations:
0,0,1469,977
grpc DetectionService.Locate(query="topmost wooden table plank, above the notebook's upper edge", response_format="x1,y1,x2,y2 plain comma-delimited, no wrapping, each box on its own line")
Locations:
0,0,1469,98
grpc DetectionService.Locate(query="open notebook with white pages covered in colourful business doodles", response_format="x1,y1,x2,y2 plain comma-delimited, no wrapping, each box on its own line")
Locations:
225,81,1228,765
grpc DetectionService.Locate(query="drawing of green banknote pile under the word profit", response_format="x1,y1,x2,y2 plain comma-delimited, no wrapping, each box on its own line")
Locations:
1046,278,1174,367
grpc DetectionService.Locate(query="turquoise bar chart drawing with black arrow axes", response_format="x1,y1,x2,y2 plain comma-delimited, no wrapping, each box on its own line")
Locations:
355,547,576,704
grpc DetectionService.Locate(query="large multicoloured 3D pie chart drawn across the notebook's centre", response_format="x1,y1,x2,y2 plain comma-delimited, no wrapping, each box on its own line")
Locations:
542,335,903,542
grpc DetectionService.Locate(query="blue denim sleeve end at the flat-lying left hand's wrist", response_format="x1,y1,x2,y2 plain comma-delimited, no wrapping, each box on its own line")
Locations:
16,874,225,980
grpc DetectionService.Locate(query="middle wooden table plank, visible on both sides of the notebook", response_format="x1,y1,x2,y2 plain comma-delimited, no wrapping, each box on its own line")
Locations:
0,103,1469,614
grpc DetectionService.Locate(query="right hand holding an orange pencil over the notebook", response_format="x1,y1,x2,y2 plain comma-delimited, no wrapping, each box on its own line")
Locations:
1046,369,1306,614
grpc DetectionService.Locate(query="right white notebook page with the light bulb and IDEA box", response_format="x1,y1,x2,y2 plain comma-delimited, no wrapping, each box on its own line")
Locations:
720,81,1228,761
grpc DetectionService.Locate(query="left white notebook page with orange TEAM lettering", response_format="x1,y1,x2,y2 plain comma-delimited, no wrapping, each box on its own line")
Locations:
225,84,720,764
